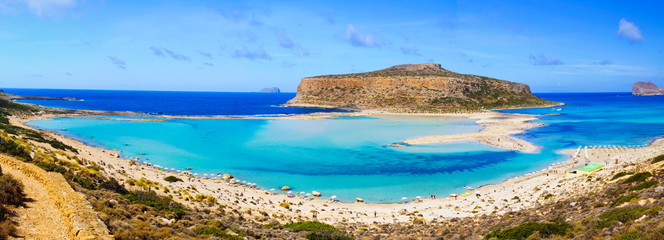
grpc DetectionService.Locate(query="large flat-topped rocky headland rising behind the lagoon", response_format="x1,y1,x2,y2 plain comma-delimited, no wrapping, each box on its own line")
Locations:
286,63,556,112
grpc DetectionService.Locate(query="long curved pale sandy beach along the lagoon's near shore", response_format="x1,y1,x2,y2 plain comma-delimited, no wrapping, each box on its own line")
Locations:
11,109,664,223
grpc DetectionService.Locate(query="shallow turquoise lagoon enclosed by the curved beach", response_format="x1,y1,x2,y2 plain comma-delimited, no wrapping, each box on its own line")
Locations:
29,117,561,202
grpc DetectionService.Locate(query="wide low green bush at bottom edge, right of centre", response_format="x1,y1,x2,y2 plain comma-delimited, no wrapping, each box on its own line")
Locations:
484,219,572,240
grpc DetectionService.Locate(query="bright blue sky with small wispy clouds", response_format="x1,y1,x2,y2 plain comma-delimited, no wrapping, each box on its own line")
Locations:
0,0,664,92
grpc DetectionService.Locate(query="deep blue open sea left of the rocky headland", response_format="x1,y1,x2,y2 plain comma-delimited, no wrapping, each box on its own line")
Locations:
4,89,340,115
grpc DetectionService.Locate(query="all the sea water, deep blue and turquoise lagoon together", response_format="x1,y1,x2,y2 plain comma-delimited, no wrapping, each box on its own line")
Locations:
5,89,664,203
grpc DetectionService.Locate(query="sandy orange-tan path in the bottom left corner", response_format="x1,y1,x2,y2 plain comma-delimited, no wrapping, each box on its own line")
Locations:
2,162,69,239
